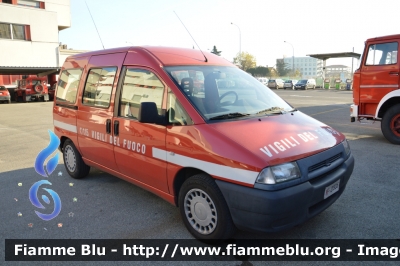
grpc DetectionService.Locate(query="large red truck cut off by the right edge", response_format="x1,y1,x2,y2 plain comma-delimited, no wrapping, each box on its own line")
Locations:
350,34,400,144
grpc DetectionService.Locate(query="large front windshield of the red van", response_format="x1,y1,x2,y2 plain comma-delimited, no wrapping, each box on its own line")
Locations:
165,66,293,121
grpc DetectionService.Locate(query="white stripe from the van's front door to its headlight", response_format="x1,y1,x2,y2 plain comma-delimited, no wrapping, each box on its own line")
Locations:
152,147,259,185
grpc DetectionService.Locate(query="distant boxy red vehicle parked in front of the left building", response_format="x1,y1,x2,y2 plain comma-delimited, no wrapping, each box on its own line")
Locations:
14,76,49,102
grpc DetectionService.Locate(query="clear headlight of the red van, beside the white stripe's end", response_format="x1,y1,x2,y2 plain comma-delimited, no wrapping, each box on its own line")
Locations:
256,162,301,184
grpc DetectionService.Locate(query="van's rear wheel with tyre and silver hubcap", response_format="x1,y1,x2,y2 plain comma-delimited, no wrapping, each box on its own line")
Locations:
63,139,90,179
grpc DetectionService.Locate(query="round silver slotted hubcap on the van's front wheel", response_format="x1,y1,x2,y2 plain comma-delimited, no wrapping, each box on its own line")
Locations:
184,189,218,235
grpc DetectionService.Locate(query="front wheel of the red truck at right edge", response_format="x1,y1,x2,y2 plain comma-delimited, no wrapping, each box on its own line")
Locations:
381,104,400,145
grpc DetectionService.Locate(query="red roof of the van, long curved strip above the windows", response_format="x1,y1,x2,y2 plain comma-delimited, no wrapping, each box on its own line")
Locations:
68,46,234,66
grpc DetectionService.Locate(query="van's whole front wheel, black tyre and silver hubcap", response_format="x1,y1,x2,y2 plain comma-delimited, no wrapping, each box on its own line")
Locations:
178,174,236,242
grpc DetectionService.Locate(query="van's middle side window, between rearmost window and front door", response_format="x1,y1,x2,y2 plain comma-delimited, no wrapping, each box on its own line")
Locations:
82,67,117,108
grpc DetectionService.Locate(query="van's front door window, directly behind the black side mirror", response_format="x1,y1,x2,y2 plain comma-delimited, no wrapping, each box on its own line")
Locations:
118,68,164,119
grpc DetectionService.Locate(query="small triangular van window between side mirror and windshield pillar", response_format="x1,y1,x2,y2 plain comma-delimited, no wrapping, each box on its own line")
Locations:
167,89,193,126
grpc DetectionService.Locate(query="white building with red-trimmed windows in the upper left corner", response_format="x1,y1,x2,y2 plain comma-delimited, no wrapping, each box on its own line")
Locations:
0,0,71,83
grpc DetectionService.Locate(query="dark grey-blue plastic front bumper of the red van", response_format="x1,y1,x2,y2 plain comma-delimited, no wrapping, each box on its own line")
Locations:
216,148,354,232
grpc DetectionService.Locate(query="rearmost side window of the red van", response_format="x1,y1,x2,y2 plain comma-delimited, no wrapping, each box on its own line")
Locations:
56,69,82,104
